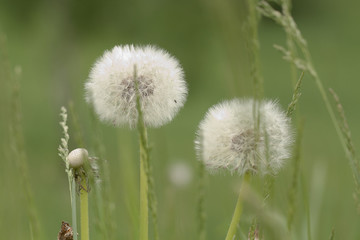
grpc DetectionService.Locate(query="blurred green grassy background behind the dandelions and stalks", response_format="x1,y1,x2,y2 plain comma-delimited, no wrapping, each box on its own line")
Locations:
0,0,360,240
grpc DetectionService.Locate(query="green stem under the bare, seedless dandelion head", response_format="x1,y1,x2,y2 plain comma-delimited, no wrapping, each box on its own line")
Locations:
80,175,89,240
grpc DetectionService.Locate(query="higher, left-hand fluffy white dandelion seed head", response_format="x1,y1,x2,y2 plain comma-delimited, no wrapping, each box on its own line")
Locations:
85,45,187,128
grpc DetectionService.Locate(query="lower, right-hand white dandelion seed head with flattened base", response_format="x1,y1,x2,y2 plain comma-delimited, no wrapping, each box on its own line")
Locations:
195,99,293,174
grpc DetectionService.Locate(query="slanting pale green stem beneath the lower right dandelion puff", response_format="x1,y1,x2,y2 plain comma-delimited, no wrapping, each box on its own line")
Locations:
225,173,250,240
